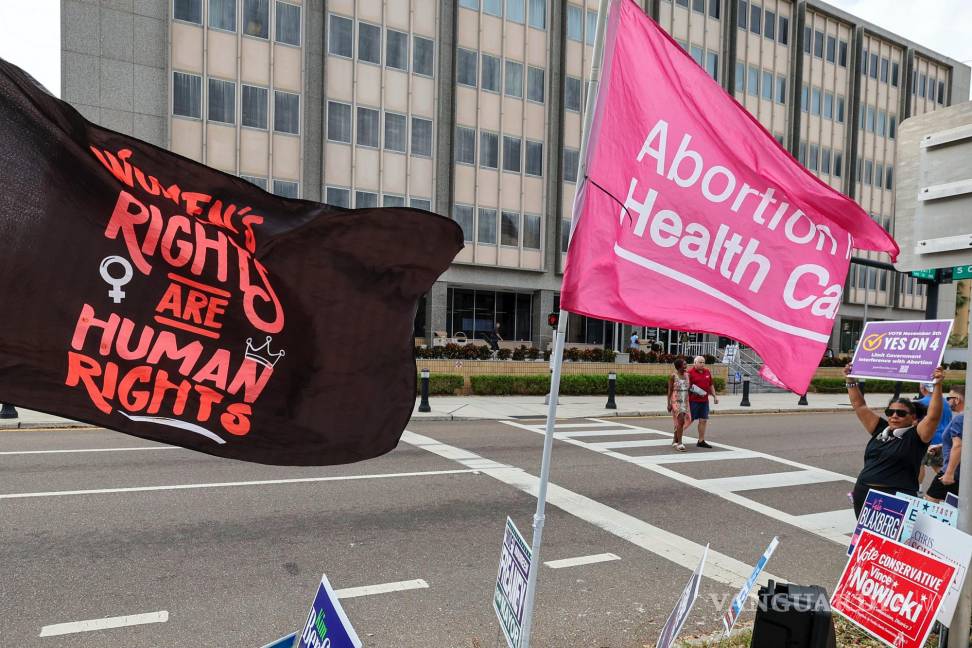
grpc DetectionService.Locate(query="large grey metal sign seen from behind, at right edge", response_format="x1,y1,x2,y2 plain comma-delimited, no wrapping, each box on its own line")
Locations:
894,102,972,272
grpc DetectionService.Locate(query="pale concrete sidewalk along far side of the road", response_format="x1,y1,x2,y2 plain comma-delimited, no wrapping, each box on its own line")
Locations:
0,393,891,431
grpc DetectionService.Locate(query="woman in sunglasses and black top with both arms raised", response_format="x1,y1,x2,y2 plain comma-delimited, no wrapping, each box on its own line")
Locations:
844,364,945,518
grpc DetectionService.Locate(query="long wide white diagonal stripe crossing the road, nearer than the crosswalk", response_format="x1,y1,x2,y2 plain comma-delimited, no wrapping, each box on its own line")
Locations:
402,430,786,587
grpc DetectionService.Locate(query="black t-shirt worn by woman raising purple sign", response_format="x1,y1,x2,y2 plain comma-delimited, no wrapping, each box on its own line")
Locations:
857,419,928,491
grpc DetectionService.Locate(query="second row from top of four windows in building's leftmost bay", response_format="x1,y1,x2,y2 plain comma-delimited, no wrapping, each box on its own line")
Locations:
172,72,300,135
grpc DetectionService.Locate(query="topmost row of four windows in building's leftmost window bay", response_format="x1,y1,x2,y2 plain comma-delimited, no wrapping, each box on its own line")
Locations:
172,0,300,47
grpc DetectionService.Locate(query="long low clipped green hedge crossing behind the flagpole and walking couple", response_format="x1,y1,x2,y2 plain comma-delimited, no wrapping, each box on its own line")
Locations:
469,374,725,396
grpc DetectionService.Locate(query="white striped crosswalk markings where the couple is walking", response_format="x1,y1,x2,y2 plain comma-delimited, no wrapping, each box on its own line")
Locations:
502,419,855,546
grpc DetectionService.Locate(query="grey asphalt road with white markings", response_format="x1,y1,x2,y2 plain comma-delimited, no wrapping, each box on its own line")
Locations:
0,412,880,648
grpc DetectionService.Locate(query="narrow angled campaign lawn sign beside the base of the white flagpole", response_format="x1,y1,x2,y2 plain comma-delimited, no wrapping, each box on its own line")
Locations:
493,517,530,648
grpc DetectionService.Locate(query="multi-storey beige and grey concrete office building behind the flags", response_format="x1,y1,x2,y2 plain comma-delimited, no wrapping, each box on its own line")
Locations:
61,0,970,352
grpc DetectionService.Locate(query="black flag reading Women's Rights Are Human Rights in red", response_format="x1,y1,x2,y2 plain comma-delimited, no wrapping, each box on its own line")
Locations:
0,54,463,465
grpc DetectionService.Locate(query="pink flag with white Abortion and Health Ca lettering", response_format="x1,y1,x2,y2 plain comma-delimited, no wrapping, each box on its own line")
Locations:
560,0,898,393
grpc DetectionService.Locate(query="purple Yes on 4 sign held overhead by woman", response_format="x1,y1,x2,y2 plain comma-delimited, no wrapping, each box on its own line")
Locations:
851,320,952,382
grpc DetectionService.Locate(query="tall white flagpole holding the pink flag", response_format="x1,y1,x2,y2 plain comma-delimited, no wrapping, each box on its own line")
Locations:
519,0,612,648
